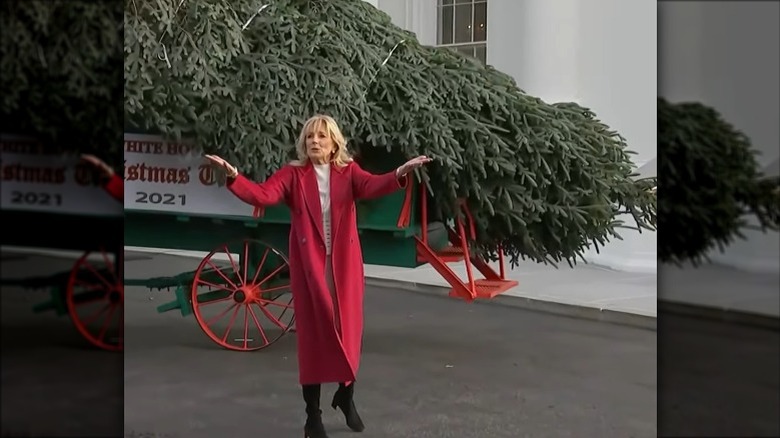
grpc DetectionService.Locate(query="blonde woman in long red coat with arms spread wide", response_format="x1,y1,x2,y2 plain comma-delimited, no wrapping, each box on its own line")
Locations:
206,115,431,438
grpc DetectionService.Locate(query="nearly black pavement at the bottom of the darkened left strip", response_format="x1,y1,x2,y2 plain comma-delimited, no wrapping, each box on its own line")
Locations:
0,253,124,438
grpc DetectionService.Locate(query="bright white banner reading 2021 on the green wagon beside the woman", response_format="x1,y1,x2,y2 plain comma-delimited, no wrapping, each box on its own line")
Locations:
125,133,254,217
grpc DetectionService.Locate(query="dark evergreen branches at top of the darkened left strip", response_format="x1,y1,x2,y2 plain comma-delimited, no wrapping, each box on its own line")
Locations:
0,0,124,164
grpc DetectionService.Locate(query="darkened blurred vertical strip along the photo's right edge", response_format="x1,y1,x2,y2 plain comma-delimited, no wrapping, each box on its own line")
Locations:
658,1,780,437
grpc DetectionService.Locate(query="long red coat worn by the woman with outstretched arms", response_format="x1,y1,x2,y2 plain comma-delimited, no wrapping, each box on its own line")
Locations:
228,162,408,385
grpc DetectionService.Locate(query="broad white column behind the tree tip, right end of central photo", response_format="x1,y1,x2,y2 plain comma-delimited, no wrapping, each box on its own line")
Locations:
578,0,658,273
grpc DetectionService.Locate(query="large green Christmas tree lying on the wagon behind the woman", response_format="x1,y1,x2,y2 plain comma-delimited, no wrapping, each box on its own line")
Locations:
125,0,656,263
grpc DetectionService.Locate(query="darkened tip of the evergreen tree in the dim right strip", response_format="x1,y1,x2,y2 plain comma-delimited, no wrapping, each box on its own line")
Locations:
658,98,780,264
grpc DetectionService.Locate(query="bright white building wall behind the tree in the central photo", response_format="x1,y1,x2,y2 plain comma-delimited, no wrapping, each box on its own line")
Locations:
378,0,657,273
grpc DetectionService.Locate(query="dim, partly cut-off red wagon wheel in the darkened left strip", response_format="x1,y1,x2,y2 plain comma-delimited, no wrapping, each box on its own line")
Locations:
65,250,125,351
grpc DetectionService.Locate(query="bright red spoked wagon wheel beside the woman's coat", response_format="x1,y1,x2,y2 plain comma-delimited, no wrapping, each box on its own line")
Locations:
190,239,295,351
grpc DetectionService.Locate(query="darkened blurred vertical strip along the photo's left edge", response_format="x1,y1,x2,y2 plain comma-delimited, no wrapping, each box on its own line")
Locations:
0,0,124,437
